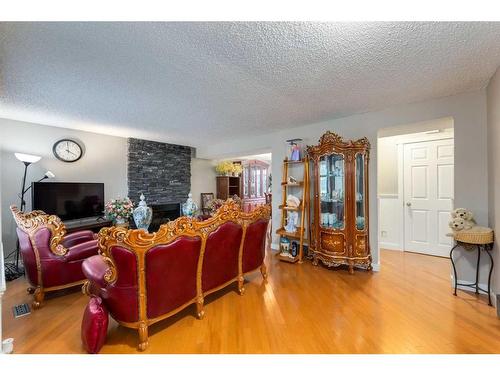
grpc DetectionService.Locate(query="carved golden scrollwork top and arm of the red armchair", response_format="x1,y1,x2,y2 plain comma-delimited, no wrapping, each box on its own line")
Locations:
10,205,68,256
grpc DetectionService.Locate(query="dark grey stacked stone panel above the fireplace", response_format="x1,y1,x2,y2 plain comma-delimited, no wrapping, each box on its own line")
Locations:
127,138,192,204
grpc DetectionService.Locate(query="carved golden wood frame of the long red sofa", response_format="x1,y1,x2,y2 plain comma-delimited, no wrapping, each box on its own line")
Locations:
93,199,271,350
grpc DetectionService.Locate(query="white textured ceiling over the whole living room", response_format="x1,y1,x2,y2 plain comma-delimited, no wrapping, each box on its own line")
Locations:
0,22,500,146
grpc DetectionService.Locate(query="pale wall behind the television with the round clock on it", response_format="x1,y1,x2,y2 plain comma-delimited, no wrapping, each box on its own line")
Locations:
0,119,127,253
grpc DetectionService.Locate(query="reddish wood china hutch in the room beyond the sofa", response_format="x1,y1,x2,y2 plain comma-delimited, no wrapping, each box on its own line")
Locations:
241,160,269,212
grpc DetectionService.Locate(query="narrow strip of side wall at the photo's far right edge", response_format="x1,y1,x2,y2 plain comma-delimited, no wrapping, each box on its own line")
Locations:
487,68,500,306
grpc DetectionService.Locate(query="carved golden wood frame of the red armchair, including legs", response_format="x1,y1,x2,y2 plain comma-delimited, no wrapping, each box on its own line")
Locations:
10,205,85,308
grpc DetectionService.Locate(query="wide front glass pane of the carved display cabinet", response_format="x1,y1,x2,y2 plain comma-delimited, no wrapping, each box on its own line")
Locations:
319,154,345,229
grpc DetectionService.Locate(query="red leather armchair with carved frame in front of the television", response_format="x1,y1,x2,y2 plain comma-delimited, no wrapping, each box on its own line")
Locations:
10,206,98,308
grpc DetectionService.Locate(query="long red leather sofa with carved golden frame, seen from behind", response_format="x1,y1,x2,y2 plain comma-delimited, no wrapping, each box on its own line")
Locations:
82,201,270,350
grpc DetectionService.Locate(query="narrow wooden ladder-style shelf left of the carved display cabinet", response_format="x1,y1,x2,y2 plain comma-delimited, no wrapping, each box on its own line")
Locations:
276,157,310,263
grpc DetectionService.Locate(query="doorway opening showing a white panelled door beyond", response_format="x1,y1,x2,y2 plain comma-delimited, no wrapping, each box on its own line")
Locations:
377,117,454,257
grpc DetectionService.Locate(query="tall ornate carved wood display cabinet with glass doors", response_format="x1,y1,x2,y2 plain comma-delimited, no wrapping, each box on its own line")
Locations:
307,131,372,273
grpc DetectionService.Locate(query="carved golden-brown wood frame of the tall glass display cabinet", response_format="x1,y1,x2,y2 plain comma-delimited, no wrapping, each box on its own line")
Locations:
307,131,371,272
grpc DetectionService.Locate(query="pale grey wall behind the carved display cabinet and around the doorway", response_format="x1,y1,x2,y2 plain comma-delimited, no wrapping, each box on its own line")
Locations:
198,90,488,279
